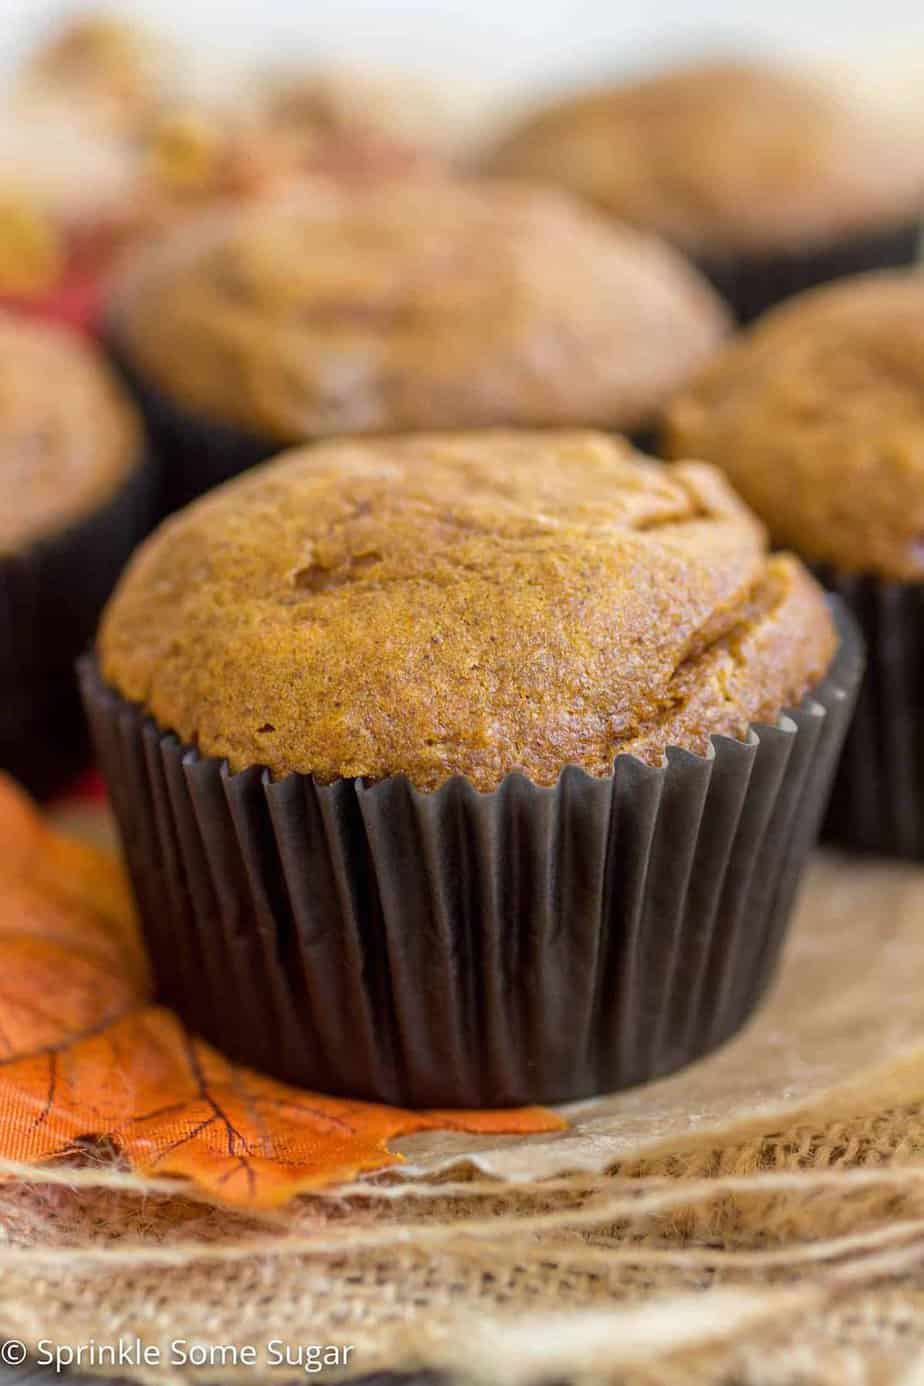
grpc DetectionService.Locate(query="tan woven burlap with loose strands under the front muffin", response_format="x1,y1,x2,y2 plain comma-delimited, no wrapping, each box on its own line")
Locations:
0,857,924,1386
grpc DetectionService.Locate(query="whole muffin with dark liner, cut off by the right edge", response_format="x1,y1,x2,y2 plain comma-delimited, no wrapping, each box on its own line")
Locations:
665,272,924,858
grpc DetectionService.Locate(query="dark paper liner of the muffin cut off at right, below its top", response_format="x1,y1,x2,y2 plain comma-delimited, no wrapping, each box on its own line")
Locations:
815,565,924,861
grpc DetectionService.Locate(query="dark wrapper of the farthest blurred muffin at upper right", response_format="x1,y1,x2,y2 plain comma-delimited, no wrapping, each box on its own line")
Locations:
697,223,923,323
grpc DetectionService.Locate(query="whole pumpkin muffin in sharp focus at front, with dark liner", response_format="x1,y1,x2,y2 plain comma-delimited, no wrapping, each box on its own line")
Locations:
85,431,856,1105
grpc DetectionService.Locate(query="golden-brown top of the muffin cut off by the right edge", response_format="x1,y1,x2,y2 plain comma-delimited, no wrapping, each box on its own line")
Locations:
665,270,924,581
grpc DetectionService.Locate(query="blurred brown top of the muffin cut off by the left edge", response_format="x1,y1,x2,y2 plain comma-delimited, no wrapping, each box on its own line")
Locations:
0,315,141,556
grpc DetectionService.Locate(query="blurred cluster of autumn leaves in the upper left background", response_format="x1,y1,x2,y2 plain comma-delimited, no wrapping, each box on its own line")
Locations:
6,15,436,328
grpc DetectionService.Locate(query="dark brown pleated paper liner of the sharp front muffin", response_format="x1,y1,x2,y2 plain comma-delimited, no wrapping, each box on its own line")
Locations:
82,604,862,1107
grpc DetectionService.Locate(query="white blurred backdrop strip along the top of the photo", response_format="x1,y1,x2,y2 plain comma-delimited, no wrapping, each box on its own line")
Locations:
0,0,924,91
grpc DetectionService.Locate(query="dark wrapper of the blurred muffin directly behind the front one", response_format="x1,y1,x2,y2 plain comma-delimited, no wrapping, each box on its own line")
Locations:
104,330,673,514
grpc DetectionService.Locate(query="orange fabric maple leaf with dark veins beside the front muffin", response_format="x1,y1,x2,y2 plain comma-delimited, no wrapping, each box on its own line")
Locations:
0,776,564,1207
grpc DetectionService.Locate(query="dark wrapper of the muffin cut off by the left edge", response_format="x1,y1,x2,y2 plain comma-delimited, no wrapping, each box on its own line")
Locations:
0,457,158,797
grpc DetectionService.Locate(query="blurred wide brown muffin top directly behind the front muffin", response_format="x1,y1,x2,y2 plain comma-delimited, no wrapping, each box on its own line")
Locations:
109,179,727,441
